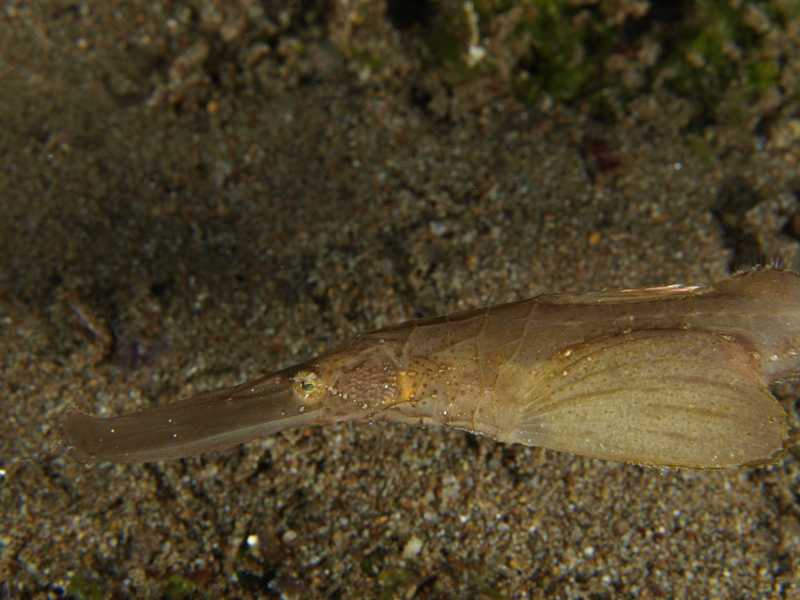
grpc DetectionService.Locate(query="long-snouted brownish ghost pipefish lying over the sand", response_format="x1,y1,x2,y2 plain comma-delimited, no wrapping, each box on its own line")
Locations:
62,268,800,469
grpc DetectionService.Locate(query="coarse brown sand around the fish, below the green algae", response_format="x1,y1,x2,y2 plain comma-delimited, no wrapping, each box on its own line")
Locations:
0,2,800,599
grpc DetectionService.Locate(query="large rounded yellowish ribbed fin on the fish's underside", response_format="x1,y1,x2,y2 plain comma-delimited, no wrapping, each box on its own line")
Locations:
509,330,788,469
